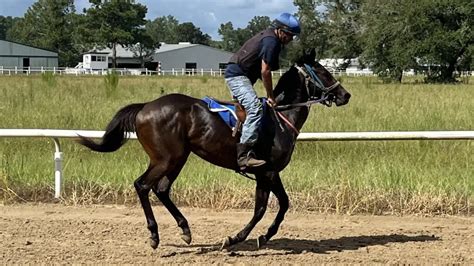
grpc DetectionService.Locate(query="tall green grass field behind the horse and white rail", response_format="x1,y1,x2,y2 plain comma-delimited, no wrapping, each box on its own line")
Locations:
0,76,474,215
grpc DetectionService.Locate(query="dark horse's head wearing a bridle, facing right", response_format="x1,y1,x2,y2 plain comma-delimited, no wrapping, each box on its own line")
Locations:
295,49,351,106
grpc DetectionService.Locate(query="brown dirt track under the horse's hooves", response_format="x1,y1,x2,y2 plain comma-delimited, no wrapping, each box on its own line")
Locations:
0,204,474,265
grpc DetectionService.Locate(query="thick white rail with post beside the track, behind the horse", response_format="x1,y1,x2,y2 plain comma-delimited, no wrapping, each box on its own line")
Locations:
0,129,474,198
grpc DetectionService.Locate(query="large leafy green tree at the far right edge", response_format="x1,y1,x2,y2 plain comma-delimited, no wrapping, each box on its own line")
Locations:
362,0,474,82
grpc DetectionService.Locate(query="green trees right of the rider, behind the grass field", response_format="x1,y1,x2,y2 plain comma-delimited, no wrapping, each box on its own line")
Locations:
294,0,474,82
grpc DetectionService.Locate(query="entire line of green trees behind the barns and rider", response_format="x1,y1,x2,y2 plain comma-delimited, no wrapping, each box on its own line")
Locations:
0,0,474,82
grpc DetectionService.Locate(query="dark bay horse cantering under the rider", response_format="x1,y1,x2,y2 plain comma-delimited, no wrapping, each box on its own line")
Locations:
79,50,350,249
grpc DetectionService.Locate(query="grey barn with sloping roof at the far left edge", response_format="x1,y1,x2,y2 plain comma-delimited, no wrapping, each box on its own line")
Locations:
0,40,58,68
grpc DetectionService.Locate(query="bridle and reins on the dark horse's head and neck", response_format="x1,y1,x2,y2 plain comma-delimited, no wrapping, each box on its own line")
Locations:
272,64,340,136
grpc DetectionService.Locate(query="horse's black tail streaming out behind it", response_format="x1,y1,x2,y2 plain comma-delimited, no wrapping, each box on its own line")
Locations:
78,103,145,152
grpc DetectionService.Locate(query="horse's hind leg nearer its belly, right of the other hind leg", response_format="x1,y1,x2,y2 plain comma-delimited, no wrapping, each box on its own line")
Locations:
152,160,192,244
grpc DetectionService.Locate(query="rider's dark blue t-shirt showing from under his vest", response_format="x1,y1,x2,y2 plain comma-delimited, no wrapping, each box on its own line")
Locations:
224,36,281,84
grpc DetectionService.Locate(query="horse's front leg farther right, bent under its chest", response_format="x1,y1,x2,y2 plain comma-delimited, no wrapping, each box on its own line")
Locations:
257,173,289,248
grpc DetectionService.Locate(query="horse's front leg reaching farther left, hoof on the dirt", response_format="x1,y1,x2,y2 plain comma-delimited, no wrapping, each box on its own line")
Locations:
221,176,270,250
